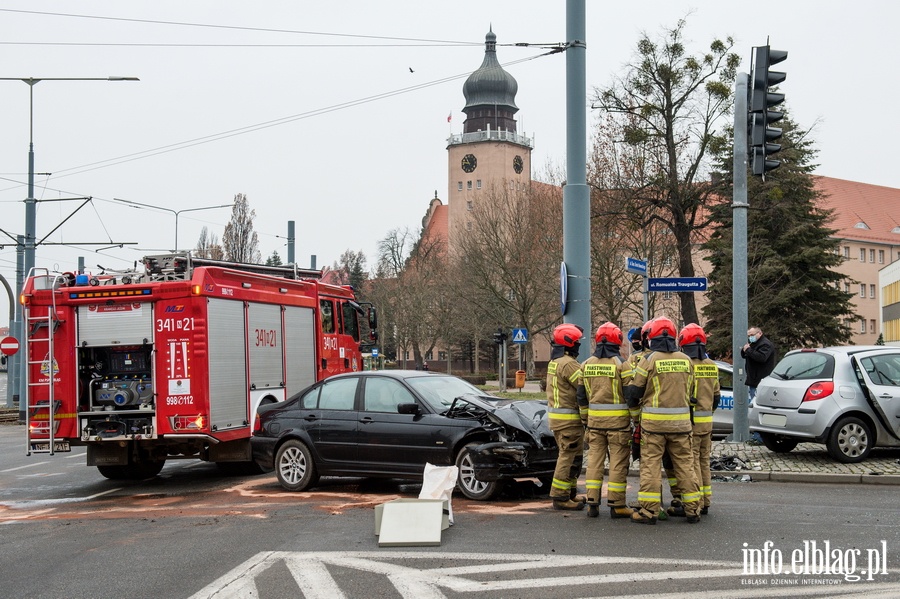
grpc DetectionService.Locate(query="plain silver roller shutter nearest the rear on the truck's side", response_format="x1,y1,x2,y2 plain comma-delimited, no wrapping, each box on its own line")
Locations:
207,298,249,431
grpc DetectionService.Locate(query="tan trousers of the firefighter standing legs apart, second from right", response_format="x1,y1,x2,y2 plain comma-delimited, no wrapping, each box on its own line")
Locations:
638,430,700,517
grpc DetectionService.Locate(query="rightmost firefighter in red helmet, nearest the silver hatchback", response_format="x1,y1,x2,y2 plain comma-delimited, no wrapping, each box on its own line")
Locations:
666,324,719,516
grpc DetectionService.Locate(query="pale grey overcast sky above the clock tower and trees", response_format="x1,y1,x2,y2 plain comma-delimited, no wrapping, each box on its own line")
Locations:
0,0,900,323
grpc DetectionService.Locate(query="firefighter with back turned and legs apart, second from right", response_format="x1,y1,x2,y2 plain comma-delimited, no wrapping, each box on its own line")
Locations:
625,317,700,524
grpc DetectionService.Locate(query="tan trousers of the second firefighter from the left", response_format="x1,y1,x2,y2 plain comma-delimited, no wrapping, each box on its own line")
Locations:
585,428,631,507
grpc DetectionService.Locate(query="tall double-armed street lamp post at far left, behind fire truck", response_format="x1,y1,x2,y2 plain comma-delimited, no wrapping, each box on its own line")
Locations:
0,76,140,419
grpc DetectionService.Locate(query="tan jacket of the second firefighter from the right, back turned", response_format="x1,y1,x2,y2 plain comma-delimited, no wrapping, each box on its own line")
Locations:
627,351,694,433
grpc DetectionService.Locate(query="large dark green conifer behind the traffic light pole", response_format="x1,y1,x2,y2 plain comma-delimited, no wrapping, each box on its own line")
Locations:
703,116,856,357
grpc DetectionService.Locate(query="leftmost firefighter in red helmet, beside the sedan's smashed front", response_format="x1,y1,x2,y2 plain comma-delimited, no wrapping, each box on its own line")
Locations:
547,323,588,510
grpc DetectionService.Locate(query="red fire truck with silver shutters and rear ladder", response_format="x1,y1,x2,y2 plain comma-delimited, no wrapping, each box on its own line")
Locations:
21,253,376,479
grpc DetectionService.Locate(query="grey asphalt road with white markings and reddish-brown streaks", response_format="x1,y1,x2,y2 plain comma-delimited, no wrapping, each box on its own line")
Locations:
0,425,900,599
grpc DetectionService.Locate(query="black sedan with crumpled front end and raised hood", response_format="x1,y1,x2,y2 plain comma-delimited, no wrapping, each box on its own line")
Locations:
251,370,557,500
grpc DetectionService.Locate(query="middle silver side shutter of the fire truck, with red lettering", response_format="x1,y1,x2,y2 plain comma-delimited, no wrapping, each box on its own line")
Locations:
247,302,284,397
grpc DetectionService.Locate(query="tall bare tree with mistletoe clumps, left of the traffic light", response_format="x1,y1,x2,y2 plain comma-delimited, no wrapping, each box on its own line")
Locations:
594,20,740,322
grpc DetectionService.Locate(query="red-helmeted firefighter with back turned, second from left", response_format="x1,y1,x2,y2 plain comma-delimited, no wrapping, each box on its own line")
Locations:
581,322,632,518
